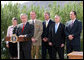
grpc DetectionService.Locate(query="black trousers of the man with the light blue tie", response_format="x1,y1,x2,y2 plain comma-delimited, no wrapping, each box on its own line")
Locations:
52,47,64,59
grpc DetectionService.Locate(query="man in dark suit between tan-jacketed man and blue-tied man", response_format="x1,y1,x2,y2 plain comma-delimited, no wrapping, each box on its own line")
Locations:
42,12,54,59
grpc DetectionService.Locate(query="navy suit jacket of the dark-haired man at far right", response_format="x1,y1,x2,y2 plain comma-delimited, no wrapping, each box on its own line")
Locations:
65,19,82,47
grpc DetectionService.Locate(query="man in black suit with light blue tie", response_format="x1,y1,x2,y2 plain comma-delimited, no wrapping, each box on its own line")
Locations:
49,15,65,59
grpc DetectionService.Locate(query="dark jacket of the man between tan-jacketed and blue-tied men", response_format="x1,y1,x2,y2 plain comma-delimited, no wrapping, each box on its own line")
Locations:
42,19,54,46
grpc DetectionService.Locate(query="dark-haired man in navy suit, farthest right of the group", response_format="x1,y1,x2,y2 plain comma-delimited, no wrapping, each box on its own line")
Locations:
65,11,82,53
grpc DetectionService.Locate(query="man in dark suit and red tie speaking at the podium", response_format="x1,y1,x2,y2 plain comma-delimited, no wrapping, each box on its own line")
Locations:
16,14,34,59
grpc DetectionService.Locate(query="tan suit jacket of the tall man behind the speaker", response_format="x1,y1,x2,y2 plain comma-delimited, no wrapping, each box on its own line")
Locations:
29,19,43,46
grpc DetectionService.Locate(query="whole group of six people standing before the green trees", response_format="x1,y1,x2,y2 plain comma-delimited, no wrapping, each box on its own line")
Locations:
6,11,82,59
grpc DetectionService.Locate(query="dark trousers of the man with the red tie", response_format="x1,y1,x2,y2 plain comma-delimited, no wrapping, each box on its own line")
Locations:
20,41,31,59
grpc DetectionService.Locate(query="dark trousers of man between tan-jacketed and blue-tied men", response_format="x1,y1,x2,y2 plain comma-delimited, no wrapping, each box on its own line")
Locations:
42,43,53,59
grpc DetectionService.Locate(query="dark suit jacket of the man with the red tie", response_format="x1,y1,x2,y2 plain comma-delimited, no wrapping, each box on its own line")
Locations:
16,22,34,45
